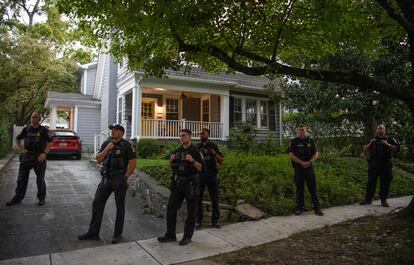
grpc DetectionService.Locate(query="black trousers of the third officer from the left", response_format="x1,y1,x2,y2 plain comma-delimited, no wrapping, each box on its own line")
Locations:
166,178,199,239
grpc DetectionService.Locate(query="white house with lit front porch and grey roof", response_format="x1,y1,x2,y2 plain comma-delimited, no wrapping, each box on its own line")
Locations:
45,49,282,153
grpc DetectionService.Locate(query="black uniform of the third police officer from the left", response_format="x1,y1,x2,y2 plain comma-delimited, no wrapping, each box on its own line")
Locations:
166,145,205,239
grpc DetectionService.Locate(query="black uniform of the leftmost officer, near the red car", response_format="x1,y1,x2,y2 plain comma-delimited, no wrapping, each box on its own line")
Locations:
13,125,52,201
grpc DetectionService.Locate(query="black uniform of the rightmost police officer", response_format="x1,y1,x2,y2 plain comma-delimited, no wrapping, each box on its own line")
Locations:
365,136,400,202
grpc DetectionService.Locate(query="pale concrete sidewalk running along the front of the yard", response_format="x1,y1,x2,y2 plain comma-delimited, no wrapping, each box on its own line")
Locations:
0,196,412,265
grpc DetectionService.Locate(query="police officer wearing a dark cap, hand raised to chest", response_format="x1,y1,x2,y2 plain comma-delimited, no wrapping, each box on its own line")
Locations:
78,124,136,244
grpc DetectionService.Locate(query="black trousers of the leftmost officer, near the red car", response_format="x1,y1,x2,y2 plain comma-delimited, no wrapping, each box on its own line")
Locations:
15,156,46,201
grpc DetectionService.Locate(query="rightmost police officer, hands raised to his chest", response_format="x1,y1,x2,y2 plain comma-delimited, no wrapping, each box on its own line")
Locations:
360,125,400,207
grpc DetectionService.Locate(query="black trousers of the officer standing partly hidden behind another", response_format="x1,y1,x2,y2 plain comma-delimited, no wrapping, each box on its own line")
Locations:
197,176,220,224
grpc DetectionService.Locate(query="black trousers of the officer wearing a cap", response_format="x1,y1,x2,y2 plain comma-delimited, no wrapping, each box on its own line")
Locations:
88,172,128,236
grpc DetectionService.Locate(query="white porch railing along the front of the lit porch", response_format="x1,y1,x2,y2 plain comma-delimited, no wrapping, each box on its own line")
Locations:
141,119,223,140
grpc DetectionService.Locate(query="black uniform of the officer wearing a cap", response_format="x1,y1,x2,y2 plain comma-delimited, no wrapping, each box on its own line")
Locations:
87,139,137,237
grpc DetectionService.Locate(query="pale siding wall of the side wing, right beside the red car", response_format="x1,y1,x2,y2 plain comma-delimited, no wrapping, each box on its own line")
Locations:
77,107,101,150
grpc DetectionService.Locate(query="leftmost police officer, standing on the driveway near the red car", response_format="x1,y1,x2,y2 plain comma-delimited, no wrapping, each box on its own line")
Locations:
6,112,52,206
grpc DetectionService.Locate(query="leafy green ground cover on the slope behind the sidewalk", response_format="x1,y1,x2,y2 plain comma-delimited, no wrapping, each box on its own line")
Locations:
138,151,414,215
